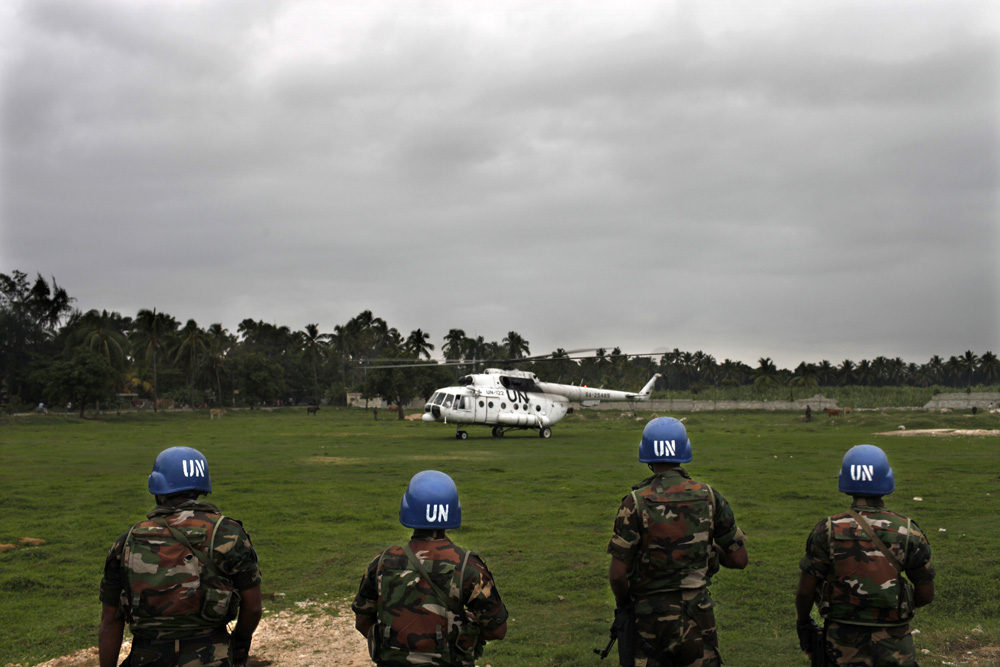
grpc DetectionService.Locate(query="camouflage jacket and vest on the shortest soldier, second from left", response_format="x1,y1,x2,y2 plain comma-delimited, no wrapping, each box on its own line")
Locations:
351,534,507,667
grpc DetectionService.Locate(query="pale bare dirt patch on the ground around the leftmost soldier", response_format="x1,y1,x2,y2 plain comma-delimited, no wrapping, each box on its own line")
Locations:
36,599,372,667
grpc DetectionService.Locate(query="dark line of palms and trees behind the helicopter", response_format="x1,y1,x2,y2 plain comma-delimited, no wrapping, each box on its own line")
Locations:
0,271,1000,416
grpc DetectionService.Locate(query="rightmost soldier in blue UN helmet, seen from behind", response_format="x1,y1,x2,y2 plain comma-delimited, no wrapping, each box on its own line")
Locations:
795,445,934,667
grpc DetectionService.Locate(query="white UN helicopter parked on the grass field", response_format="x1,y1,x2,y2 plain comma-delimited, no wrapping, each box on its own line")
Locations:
422,368,660,440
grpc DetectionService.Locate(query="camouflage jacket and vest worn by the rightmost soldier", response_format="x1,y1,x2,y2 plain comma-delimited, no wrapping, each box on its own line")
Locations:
799,499,934,626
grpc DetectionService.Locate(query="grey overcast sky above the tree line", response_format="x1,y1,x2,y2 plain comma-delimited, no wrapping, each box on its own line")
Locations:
0,0,1000,368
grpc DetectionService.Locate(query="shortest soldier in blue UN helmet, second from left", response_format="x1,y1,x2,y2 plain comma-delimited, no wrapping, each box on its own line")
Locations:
351,470,507,667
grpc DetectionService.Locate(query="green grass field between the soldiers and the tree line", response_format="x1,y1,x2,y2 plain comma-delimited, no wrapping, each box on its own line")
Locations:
0,408,1000,667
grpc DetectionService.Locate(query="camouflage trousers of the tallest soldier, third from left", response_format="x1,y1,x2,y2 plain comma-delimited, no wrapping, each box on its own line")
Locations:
635,588,722,667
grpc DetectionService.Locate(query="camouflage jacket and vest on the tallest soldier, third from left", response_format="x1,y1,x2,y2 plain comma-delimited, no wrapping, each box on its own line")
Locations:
608,467,745,598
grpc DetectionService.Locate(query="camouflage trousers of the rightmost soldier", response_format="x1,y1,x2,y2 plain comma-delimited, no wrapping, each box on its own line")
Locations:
826,621,917,667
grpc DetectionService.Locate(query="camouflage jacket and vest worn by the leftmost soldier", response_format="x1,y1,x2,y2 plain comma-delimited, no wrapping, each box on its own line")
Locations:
100,500,261,639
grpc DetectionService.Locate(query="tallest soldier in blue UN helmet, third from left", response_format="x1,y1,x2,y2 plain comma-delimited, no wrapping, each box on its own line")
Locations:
608,417,747,667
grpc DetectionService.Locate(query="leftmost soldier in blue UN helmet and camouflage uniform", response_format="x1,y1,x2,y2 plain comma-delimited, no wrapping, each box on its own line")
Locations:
99,447,262,667
